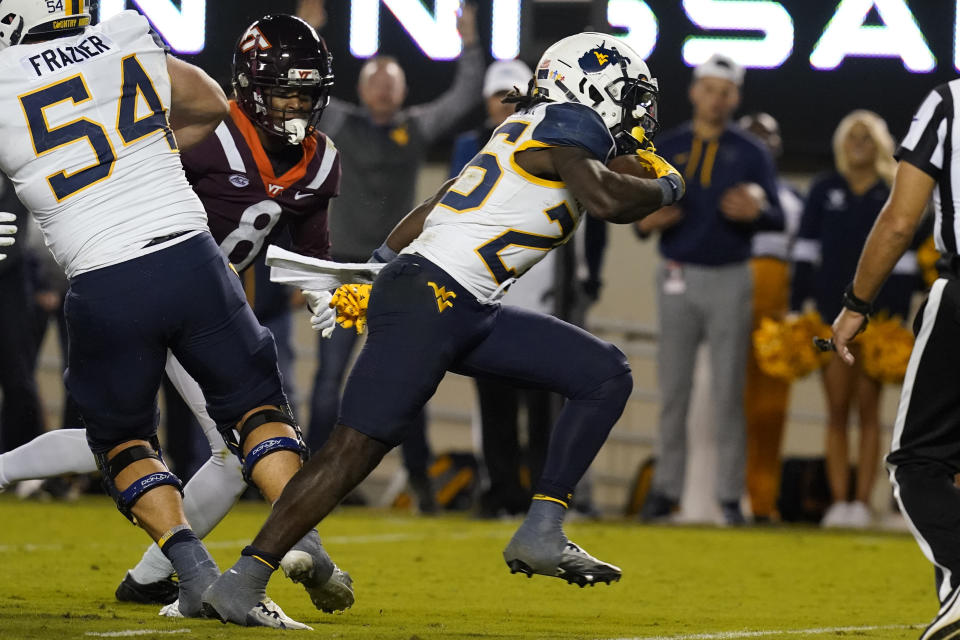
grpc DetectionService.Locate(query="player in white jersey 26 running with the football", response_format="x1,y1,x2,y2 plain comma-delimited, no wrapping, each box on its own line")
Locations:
204,33,683,624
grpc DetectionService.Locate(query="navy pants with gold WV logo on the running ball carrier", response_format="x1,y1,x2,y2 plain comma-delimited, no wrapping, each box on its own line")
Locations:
340,255,633,498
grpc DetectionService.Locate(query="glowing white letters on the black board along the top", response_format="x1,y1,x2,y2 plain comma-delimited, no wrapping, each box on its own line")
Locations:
107,0,960,73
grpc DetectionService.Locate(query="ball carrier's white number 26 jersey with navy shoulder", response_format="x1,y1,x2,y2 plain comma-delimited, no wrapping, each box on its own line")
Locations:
403,103,615,300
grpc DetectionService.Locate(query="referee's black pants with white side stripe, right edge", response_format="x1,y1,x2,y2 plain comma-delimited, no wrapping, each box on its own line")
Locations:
887,278,960,602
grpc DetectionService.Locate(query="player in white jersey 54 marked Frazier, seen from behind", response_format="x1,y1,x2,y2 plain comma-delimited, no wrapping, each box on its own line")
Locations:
0,0,329,626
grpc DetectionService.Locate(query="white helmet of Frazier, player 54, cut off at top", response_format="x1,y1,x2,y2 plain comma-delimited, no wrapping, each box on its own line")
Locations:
0,0,97,49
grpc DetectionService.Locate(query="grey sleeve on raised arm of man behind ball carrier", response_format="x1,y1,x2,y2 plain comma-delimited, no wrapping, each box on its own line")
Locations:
409,45,486,144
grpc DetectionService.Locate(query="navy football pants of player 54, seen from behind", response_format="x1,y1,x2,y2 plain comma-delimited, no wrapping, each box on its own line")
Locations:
65,232,286,453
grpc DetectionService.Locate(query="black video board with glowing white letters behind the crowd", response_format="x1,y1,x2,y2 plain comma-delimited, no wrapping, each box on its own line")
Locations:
101,0,960,156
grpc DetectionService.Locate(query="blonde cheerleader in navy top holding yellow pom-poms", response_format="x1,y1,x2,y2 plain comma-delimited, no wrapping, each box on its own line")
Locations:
790,110,920,527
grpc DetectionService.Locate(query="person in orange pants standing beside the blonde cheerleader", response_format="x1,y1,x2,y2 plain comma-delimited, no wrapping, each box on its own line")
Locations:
739,113,803,523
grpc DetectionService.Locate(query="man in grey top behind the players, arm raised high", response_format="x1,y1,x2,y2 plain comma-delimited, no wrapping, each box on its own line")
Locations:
307,4,485,511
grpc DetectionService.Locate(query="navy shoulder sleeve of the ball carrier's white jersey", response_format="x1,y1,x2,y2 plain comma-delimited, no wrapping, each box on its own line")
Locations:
531,102,615,162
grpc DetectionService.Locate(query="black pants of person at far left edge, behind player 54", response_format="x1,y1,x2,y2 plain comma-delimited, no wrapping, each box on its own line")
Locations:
0,261,43,452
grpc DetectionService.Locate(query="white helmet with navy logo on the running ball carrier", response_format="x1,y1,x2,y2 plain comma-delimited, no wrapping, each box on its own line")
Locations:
535,32,659,151
